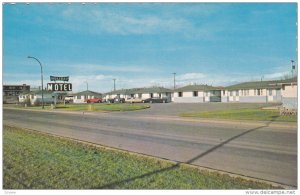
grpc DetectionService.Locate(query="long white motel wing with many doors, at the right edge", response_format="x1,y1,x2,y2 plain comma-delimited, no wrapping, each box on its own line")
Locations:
221,77,297,106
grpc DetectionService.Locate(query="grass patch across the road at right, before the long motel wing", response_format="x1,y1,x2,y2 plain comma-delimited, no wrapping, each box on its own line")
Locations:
179,108,297,122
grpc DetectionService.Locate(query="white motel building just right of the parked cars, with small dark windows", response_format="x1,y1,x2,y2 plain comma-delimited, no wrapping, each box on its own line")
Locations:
173,85,223,103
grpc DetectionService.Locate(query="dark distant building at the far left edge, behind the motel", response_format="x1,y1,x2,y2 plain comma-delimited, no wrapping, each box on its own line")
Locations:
3,84,30,103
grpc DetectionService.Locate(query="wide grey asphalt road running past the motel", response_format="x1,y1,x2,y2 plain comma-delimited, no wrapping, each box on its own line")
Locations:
3,104,297,186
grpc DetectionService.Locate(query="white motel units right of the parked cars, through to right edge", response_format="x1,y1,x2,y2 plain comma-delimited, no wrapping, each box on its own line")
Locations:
173,77,297,108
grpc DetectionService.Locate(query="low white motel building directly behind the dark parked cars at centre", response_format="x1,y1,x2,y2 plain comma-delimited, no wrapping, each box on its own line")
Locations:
105,87,172,101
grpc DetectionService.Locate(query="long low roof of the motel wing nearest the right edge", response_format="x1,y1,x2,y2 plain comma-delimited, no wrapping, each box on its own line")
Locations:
225,77,297,90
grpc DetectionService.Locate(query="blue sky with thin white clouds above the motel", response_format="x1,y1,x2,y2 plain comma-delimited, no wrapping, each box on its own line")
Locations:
3,3,297,92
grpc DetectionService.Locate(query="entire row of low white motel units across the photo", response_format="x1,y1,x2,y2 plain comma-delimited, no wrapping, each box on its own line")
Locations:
19,77,297,108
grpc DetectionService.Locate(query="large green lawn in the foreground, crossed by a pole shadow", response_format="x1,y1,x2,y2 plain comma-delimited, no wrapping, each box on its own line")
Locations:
3,126,274,189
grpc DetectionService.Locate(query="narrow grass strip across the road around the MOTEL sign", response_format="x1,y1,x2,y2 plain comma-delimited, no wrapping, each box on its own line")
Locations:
4,103,150,112
